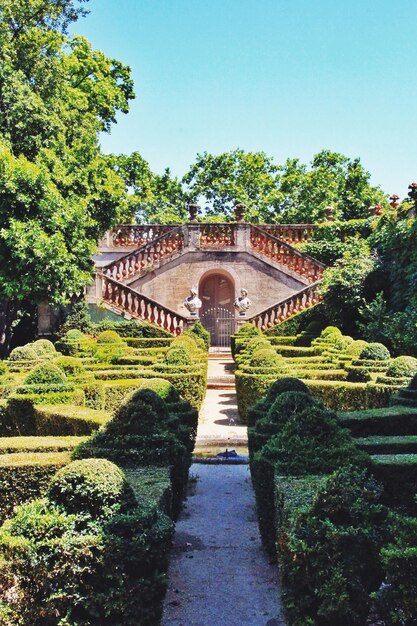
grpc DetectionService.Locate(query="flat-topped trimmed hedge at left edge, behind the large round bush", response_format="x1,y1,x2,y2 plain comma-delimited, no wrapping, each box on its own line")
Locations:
0,452,70,523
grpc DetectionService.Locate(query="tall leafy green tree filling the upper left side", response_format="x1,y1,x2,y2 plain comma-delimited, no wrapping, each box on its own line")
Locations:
0,0,134,354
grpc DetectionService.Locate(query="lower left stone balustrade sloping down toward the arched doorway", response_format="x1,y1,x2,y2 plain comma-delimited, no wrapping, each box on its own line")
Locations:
102,275,187,335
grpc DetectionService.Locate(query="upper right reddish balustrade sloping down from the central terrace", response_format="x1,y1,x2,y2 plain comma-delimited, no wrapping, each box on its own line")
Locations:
250,225,325,283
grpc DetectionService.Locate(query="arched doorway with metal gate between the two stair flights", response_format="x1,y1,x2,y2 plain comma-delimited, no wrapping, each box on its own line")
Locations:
199,273,235,348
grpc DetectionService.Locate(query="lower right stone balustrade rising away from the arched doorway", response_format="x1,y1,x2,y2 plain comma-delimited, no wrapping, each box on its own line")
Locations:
248,282,322,330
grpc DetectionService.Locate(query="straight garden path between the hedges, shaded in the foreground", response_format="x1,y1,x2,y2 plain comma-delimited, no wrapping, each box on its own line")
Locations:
162,356,285,626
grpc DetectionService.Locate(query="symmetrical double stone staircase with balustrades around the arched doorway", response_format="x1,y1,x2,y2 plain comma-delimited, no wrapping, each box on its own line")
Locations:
88,223,324,334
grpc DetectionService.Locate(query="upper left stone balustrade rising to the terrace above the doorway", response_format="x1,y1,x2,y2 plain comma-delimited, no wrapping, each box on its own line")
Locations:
103,226,184,281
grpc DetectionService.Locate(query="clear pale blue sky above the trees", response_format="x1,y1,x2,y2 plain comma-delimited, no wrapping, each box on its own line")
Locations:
73,0,417,197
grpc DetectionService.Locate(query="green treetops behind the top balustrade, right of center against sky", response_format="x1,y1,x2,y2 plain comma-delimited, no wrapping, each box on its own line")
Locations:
183,149,386,223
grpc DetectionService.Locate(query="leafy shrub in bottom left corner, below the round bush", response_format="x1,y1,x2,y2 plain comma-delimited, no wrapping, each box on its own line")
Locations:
0,476,172,626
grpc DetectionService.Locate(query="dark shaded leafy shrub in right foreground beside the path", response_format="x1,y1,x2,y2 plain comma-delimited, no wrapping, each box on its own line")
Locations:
278,466,387,626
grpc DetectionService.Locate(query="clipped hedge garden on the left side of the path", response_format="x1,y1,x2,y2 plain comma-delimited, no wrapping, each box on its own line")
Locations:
0,323,208,626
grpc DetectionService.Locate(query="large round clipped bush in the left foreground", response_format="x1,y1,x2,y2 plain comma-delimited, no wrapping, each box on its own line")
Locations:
48,459,135,519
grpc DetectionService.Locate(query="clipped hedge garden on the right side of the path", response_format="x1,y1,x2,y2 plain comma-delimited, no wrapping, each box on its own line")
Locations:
232,323,417,626
